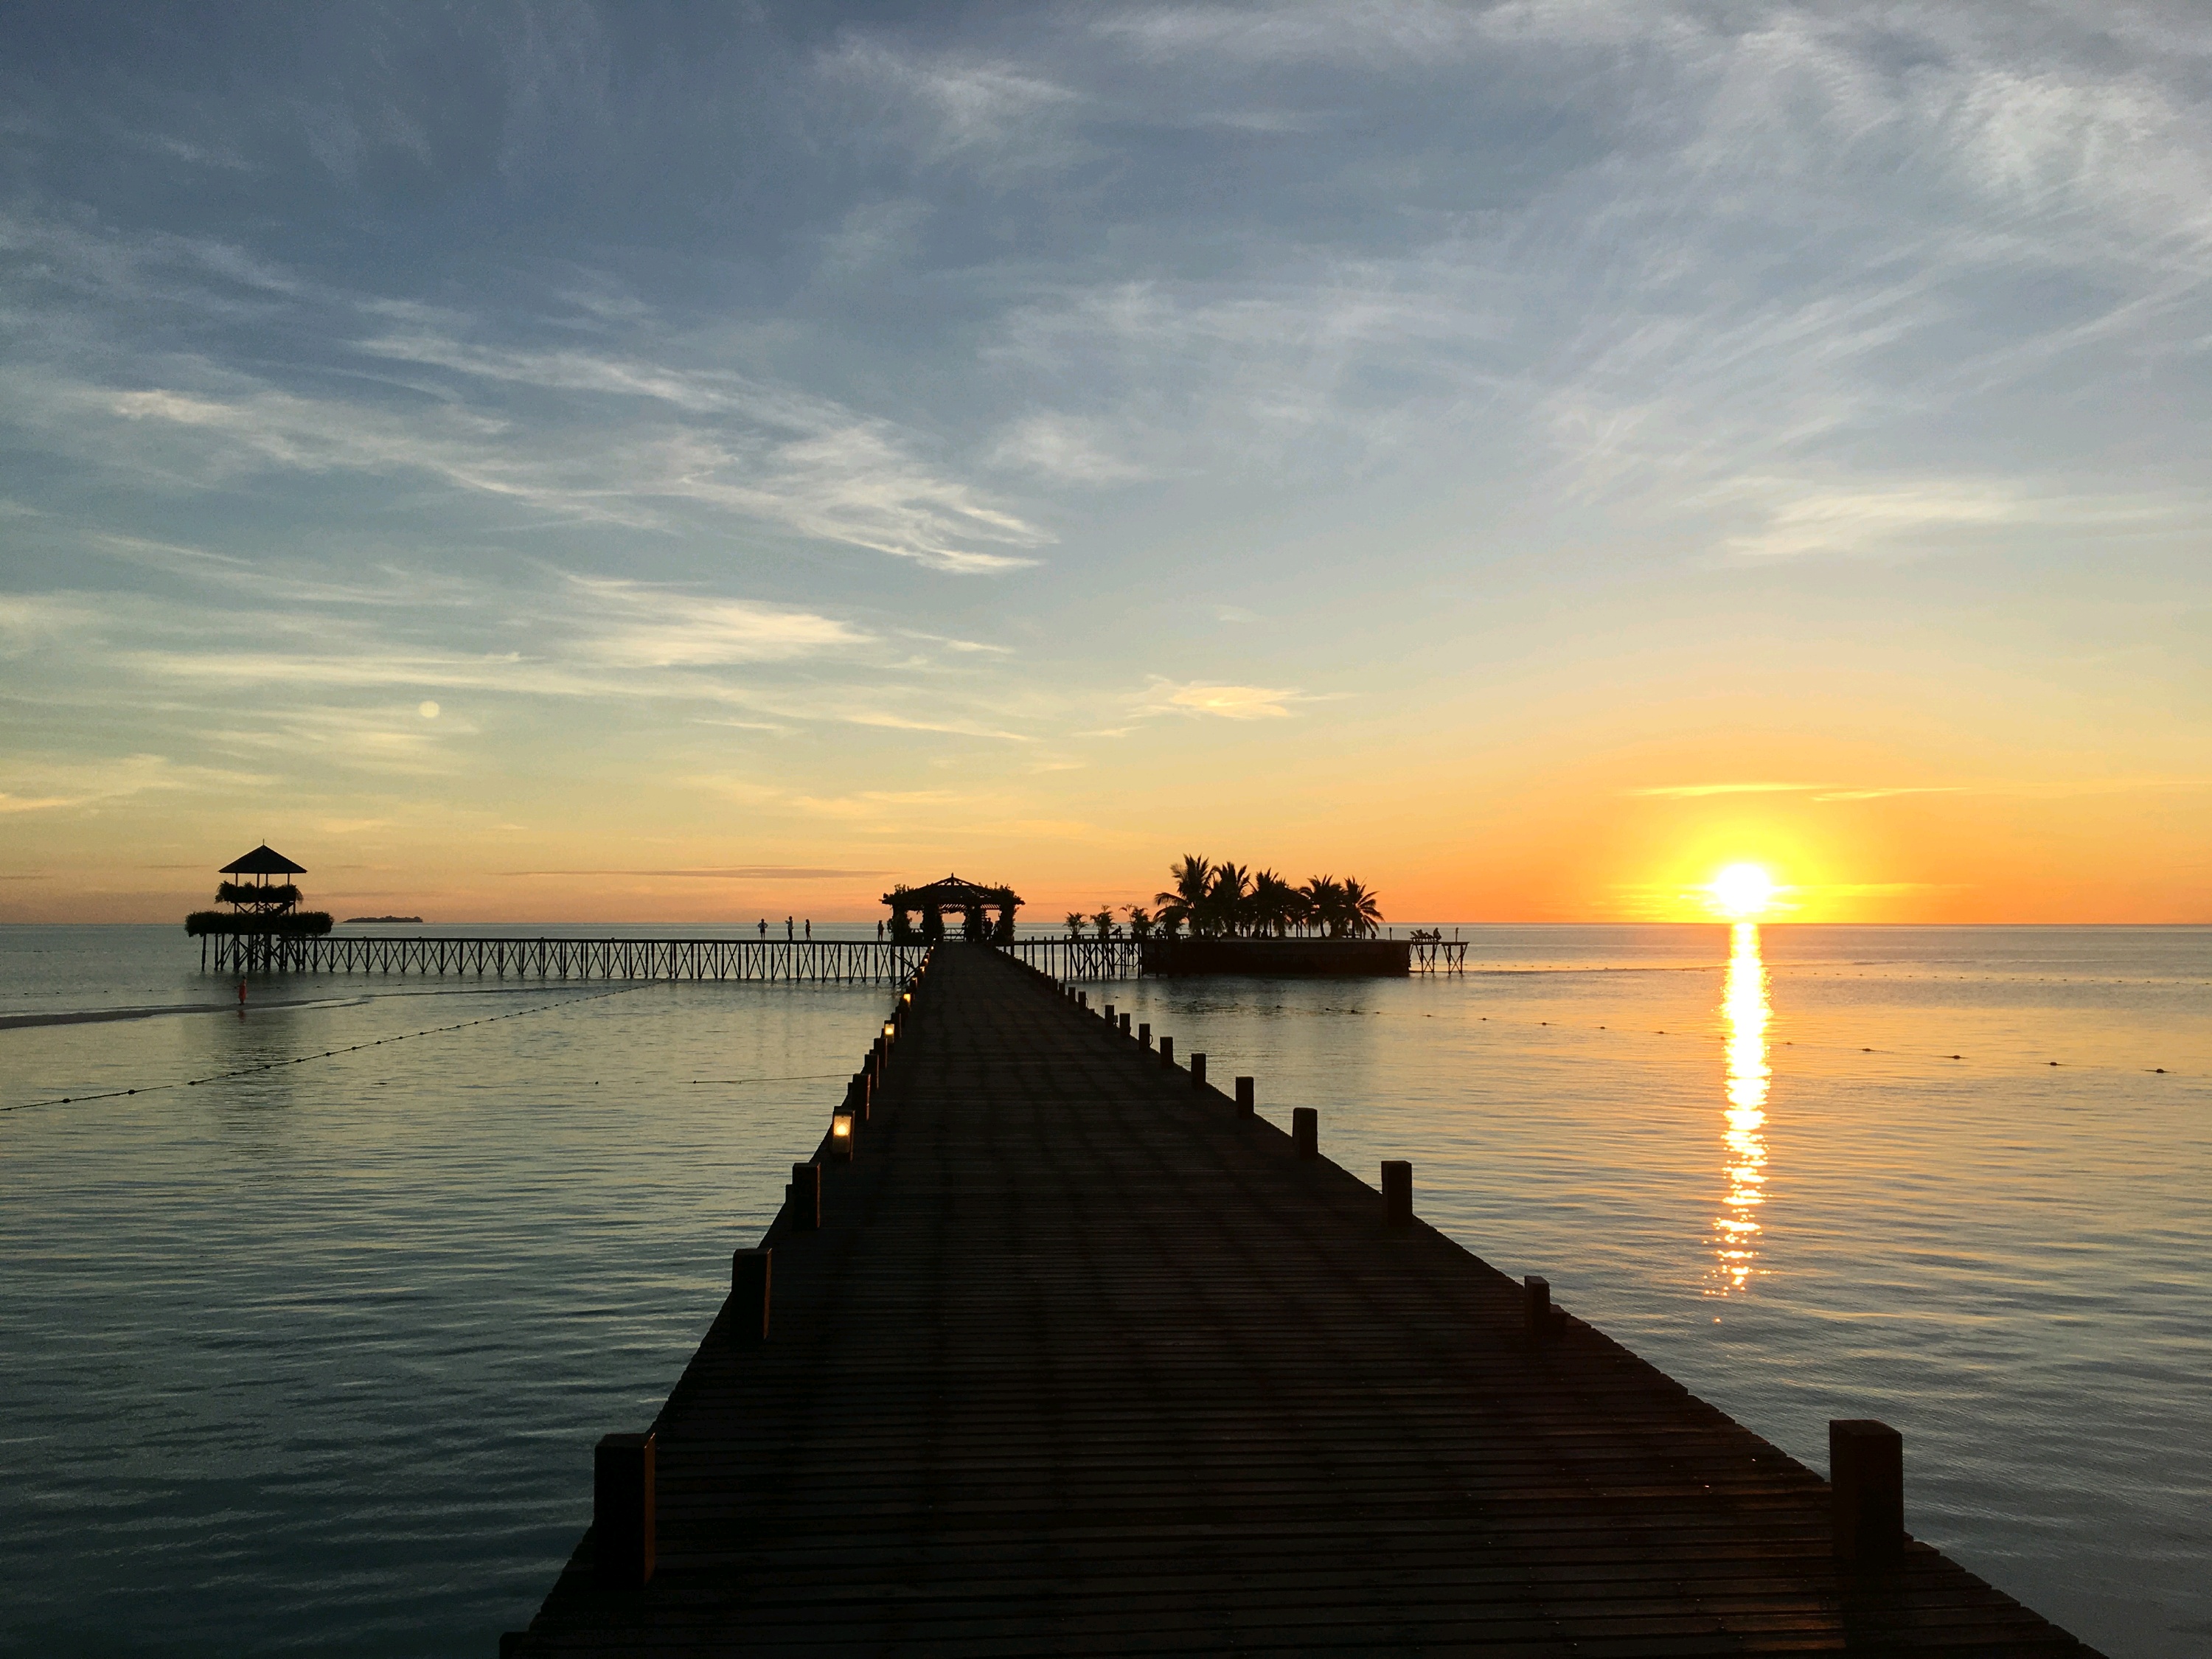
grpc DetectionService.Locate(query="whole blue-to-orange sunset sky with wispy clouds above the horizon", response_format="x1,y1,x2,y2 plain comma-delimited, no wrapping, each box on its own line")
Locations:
0,0,2212,922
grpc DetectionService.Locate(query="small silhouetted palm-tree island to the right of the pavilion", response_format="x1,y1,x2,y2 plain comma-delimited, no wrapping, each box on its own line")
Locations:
1066,854,1413,978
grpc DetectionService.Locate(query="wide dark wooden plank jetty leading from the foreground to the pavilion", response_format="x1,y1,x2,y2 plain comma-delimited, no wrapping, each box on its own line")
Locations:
502,947,2086,1659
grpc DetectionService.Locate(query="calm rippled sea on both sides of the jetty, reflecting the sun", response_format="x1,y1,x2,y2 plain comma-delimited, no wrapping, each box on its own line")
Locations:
0,927,2212,1659
